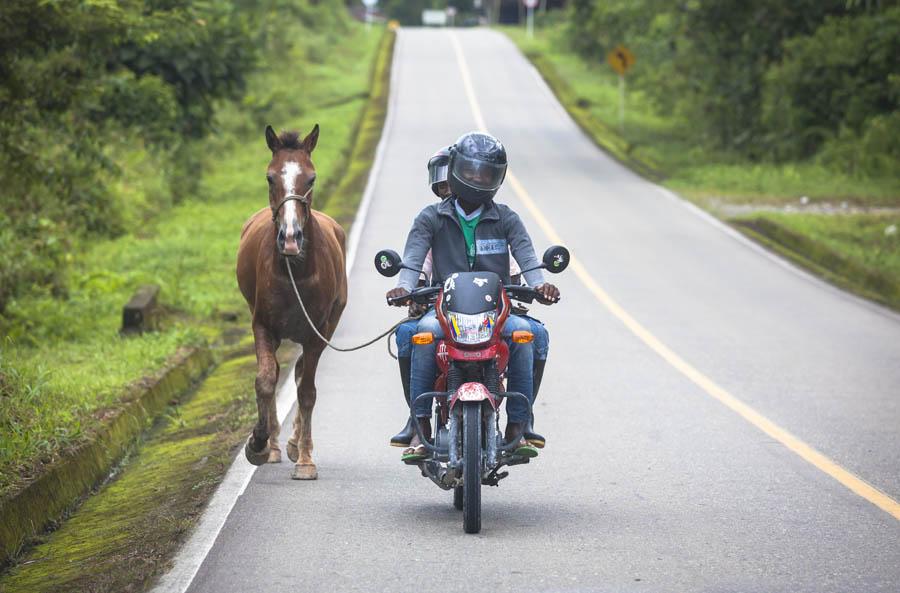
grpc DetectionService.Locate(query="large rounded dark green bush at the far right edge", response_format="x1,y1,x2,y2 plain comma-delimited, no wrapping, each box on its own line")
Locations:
763,8,900,166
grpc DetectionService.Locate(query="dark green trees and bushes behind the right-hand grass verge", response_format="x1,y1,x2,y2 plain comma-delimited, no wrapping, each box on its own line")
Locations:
568,0,900,168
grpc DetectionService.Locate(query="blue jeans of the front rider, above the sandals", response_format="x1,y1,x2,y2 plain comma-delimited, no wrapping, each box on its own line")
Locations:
410,309,546,422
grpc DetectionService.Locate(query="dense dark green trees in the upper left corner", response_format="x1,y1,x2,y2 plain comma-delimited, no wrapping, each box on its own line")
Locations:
0,0,255,311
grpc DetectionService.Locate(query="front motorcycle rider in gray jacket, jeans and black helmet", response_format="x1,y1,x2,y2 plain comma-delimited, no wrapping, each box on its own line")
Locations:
387,132,559,459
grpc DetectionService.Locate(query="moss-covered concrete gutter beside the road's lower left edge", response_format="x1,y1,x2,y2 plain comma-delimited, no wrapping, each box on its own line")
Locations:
0,353,256,593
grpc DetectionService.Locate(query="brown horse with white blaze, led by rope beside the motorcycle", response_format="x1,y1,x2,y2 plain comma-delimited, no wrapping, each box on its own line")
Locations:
237,124,347,480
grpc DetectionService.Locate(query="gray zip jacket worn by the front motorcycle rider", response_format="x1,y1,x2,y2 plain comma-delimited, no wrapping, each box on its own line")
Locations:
397,198,544,290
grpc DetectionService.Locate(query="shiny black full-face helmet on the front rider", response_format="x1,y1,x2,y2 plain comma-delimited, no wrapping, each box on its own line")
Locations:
449,132,506,204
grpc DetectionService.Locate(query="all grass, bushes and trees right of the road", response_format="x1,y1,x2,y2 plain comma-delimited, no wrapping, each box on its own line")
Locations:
505,0,900,308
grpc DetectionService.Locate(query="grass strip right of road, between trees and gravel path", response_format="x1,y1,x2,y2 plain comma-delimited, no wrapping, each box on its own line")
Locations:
506,28,900,207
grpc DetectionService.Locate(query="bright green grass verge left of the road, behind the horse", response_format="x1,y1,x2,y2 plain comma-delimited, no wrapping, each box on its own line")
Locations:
0,21,382,497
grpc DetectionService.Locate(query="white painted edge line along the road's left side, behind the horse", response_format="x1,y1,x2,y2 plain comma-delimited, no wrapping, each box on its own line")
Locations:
151,31,400,593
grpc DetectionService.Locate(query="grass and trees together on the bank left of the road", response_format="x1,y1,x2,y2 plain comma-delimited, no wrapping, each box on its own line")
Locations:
0,0,386,500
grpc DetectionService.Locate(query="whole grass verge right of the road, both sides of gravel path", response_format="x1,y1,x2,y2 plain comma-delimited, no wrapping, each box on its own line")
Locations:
503,25,900,309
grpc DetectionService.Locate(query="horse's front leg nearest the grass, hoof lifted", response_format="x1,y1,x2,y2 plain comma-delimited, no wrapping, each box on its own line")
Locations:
244,325,278,465
